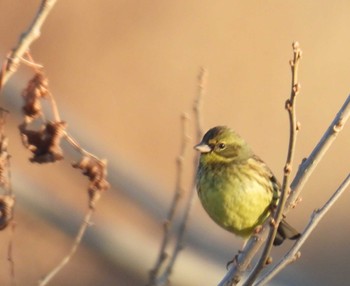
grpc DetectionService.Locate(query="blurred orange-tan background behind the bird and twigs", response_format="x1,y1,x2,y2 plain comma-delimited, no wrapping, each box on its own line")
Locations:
0,0,350,286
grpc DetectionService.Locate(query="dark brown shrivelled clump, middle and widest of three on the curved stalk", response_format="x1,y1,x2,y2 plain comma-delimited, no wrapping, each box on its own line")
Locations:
19,121,67,163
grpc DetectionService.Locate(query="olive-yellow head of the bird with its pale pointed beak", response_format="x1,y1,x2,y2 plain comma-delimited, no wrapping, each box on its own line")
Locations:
194,126,252,163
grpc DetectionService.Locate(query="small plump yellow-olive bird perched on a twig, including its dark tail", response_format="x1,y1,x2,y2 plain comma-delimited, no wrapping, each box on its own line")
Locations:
194,126,300,245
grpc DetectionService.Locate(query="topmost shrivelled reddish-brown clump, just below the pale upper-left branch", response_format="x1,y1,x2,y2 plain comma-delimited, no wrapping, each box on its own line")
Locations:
22,72,49,121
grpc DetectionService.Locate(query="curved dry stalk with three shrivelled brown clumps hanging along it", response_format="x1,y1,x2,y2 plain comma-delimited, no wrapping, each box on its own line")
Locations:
19,57,110,286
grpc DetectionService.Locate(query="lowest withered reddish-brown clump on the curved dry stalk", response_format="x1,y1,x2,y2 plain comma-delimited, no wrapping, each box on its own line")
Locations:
72,156,110,208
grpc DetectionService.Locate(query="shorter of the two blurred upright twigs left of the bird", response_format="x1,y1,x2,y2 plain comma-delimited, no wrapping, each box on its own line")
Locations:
148,114,189,285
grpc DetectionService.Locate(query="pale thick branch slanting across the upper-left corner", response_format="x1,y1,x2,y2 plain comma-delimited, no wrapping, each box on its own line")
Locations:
0,0,56,89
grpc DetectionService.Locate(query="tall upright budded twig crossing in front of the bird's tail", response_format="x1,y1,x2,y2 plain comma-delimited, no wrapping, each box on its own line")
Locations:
244,42,301,286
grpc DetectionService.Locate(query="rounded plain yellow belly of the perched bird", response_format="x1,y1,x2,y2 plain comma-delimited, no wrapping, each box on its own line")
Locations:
198,165,273,237
